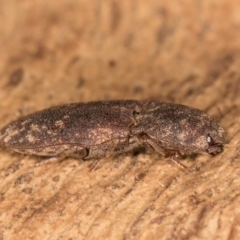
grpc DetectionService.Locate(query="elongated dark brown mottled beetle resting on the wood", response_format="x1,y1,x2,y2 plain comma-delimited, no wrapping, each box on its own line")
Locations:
0,100,226,159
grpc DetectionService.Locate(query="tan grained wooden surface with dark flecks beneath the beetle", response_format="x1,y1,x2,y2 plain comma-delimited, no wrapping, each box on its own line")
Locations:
0,0,240,240
